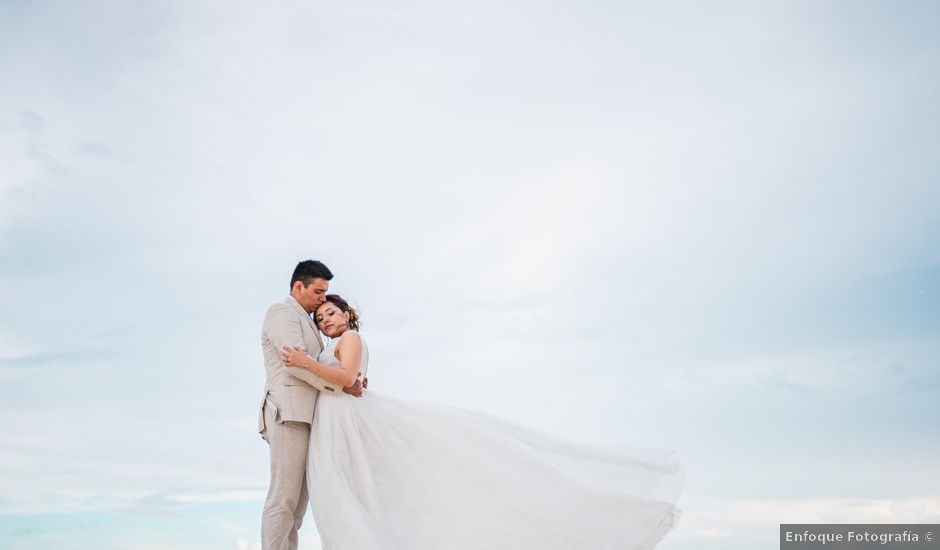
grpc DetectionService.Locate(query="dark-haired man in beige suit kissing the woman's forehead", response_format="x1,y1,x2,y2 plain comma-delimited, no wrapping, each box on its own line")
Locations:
258,260,362,550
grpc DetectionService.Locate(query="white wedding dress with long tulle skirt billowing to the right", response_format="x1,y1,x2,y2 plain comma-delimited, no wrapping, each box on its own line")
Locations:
308,332,682,550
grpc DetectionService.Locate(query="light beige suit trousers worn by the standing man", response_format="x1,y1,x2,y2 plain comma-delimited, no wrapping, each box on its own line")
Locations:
261,400,310,550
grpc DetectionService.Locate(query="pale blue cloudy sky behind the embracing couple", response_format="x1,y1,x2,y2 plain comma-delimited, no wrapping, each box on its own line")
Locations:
0,0,940,550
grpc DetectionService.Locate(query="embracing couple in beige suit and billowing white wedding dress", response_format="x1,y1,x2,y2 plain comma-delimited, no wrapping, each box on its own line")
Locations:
259,260,682,550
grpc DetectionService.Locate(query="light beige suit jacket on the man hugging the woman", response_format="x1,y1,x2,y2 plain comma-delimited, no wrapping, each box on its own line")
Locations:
258,296,343,433
